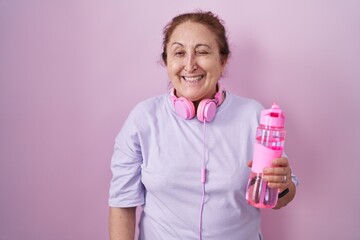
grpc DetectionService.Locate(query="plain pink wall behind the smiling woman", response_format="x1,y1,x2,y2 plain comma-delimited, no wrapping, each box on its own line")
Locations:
0,0,360,240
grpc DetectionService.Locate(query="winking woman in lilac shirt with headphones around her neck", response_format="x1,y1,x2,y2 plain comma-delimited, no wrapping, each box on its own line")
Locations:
109,12,297,240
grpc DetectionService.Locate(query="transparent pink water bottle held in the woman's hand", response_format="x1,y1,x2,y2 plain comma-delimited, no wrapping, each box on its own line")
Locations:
246,103,286,208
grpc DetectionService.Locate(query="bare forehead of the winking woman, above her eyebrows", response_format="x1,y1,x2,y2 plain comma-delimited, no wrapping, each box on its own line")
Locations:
169,22,216,47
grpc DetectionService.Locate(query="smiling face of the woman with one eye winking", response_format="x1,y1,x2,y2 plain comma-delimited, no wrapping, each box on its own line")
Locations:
166,22,225,102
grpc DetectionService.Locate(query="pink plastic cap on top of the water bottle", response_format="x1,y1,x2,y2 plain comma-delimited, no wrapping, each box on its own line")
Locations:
260,103,285,127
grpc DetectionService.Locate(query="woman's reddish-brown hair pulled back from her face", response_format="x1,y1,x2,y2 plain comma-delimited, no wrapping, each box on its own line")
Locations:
162,11,230,65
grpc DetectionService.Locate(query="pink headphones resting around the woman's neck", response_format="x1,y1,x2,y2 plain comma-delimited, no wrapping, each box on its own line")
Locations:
170,83,224,122
